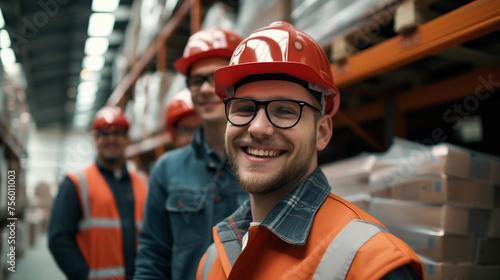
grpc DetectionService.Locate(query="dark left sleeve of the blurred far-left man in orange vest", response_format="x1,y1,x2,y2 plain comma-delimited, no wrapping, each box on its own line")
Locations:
48,178,89,280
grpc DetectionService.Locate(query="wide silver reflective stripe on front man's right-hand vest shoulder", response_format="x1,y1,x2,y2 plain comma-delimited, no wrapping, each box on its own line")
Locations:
312,220,390,280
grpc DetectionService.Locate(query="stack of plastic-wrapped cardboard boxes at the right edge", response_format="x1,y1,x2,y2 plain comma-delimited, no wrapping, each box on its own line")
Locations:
369,139,500,279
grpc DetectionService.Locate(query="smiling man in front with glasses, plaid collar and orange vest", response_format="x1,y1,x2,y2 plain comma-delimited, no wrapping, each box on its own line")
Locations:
197,22,422,280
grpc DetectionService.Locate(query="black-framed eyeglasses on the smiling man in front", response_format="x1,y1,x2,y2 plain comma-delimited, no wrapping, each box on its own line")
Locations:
223,97,320,128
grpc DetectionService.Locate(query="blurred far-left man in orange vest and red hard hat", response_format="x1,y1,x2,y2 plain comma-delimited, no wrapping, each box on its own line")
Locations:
48,106,147,280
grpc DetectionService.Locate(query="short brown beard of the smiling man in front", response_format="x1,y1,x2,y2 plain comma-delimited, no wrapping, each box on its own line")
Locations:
227,136,316,195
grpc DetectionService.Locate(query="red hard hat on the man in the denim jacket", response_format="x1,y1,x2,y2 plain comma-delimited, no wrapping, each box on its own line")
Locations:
174,27,243,76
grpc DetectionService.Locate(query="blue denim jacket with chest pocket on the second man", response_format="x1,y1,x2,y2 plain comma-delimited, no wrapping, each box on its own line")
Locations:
134,127,248,280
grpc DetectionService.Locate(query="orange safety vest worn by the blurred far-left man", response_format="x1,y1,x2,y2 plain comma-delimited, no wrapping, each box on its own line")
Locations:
68,163,147,280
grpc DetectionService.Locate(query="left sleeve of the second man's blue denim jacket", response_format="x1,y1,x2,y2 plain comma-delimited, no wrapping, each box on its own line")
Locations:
134,158,172,279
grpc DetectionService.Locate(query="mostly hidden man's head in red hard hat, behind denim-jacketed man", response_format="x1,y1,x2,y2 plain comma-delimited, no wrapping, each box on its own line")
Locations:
165,88,201,149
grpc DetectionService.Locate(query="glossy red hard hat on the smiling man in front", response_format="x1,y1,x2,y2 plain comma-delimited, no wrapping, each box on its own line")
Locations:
215,21,340,116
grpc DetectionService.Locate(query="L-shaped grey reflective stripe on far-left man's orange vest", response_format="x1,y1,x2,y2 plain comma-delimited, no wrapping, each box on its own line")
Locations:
76,172,122,230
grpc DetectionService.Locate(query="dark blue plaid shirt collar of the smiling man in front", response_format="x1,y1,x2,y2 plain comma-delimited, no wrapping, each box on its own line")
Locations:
217,168,331,245
